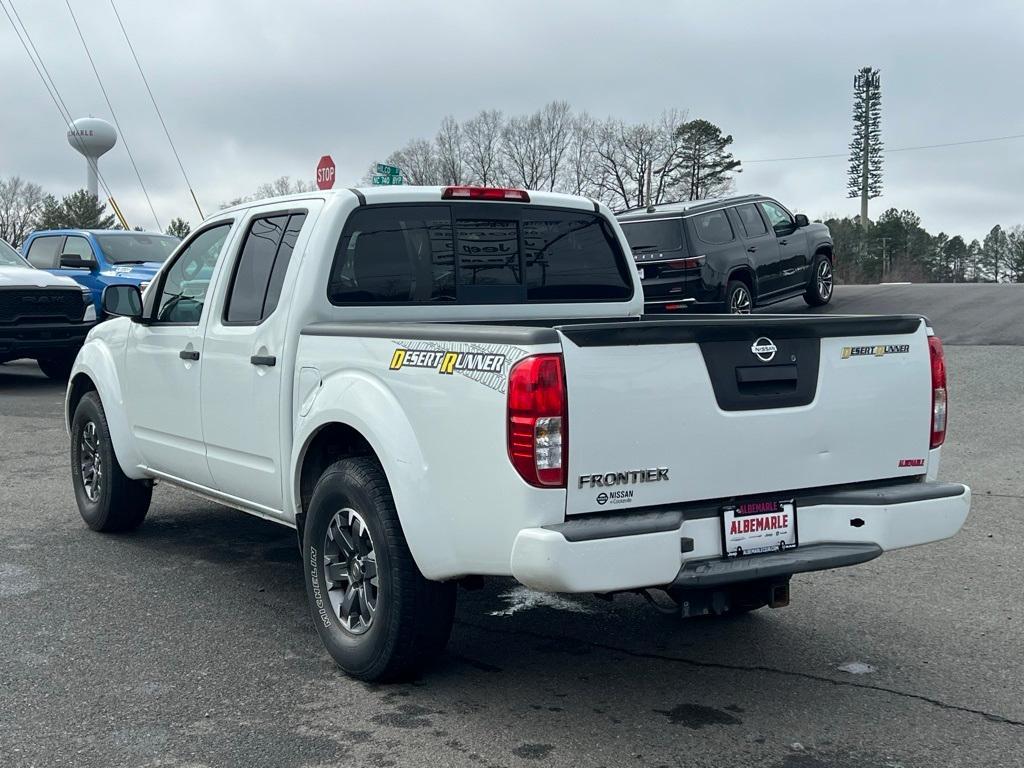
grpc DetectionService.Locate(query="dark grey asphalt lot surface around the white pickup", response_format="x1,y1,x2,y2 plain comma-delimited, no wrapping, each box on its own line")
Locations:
0,286,1024,768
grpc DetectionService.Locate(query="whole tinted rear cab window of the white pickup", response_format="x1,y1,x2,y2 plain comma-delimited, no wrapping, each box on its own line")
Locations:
328,204,633,304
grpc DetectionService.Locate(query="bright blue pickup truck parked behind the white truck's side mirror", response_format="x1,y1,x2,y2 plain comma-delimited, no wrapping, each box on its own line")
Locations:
22,229,180,315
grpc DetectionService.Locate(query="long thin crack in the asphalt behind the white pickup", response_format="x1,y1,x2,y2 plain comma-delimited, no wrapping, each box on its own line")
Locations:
456,620,1024,728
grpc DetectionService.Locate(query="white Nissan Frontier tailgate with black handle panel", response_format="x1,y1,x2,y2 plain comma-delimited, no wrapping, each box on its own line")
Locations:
557,315,932,515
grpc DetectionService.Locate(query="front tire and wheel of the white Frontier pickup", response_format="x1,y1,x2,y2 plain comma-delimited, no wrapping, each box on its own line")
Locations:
71,392,153,532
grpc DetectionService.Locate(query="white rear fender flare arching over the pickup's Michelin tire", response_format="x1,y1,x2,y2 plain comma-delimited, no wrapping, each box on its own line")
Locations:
290,371,455,579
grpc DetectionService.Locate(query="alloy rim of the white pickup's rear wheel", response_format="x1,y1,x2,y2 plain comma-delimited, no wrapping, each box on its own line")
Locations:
324,508,380,635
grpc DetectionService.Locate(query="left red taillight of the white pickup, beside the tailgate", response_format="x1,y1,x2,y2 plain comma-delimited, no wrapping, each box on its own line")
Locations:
508,354,569,487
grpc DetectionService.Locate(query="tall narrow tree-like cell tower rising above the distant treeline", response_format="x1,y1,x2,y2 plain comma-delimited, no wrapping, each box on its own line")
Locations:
847,67,882,230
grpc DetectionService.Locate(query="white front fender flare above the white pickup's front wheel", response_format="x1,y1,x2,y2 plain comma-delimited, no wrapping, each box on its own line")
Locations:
65,341,148,480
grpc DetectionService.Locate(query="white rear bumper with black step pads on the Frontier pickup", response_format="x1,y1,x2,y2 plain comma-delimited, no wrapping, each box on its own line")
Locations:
511,482,971,593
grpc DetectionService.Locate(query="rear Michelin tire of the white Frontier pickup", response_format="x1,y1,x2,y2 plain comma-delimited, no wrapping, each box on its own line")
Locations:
302,457,456,682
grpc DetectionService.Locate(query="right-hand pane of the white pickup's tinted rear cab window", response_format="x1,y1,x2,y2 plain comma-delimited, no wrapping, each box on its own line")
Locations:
522,210,630,301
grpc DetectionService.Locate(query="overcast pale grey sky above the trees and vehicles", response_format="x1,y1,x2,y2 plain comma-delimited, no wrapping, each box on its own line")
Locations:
0,0,1024,238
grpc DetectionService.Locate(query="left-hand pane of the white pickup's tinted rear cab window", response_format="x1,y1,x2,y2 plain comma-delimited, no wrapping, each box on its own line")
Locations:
328,206,456,304
